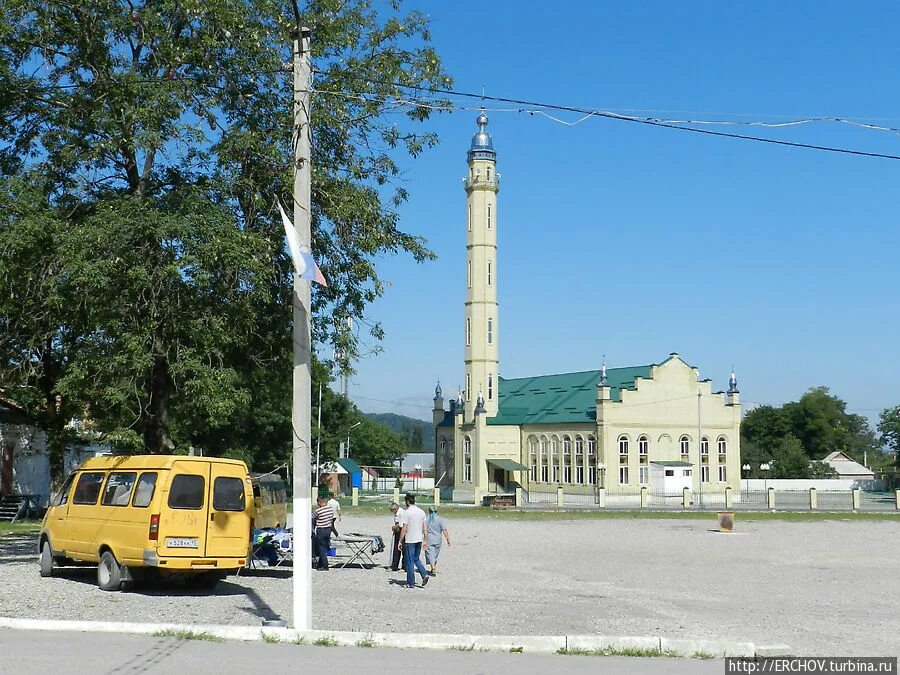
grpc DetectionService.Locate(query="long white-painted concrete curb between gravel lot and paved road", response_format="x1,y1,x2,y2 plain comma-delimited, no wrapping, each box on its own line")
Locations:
0,617,790,658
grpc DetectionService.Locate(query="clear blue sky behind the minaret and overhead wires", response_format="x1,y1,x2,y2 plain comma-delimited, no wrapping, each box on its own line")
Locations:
342,0,900,428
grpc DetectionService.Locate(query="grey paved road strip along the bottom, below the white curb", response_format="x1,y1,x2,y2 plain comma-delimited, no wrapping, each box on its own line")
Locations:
0,629,724,675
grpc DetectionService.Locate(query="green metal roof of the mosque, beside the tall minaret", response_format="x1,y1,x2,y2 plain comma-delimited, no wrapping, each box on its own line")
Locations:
487,365,653,425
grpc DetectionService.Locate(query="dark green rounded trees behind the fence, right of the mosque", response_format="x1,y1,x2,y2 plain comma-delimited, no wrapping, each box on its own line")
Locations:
741,387,880,478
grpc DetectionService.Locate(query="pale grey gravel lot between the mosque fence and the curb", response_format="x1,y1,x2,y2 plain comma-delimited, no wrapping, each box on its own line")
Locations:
0,515,900,656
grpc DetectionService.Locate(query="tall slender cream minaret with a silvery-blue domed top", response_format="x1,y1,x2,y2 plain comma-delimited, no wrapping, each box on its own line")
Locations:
464,111,500,417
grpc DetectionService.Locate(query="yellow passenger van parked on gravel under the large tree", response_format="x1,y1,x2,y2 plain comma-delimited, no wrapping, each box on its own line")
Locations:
39,455,253,591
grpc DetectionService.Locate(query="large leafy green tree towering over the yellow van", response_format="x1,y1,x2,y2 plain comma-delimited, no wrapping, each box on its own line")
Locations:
0,0,449,464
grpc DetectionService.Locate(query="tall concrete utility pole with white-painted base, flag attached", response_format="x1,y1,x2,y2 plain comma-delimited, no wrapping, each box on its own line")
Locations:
291,25,312,630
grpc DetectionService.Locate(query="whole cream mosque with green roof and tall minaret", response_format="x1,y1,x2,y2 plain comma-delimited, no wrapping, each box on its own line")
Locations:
433,112,741,503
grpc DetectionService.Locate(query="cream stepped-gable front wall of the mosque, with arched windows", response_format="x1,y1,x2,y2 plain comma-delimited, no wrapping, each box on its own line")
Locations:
597,356,741,491
